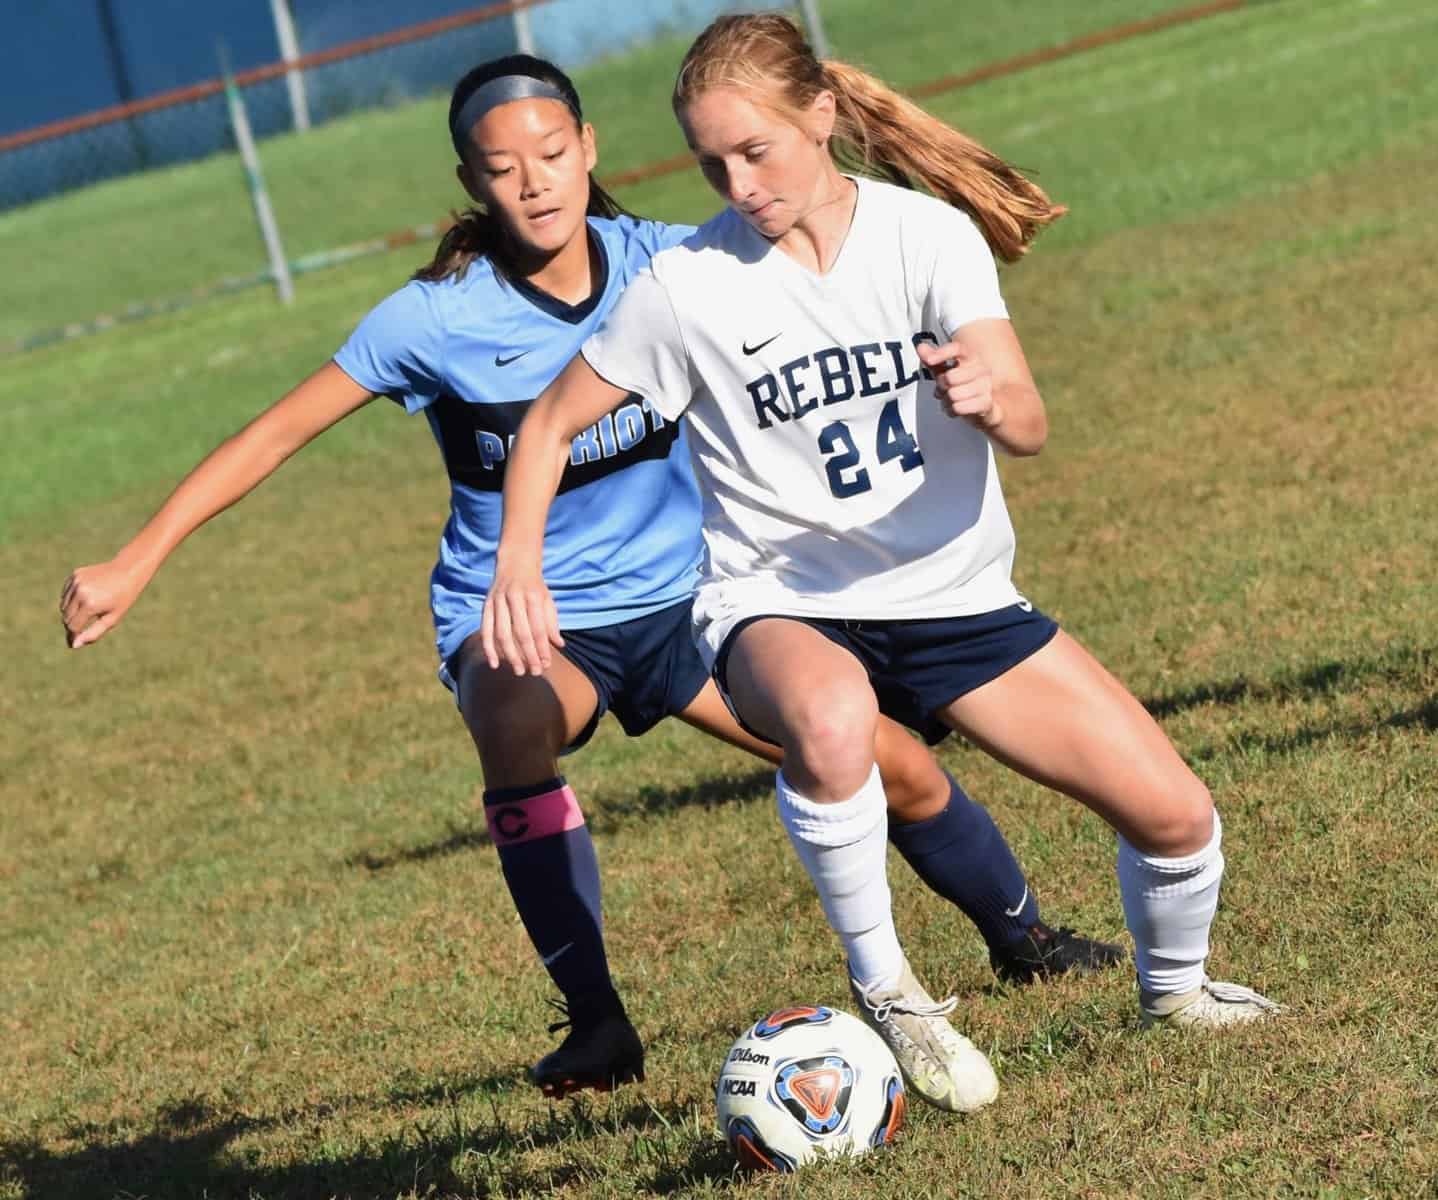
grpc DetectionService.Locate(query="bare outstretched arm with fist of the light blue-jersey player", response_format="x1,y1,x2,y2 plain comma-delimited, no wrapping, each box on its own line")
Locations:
60,363,374,649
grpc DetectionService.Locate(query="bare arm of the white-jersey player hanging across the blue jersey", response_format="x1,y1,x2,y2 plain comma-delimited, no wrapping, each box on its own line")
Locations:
480,354,627,675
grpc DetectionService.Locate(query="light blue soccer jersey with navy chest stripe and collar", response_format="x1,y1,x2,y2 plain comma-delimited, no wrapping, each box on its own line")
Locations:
335,217,702,660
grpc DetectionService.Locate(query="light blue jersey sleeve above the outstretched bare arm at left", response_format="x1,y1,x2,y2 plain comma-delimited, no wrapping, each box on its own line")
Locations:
335,281,444,413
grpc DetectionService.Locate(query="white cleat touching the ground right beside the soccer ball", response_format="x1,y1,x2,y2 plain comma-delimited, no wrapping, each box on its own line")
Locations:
848,963,998,1112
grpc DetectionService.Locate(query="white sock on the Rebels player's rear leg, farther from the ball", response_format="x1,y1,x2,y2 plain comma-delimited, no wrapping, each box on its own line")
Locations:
1119,809,1224,996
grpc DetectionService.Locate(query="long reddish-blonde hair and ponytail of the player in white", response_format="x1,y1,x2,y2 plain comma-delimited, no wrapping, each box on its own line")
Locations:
674,13,1067,262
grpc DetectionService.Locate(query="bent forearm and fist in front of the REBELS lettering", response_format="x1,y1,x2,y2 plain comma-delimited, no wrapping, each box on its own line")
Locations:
917,319,1048,455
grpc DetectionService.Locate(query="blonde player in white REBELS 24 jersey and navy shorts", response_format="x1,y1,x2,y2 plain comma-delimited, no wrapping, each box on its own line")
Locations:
482,14,1277,1095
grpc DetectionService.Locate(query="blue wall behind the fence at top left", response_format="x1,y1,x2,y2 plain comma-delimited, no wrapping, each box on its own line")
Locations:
0,0,772,209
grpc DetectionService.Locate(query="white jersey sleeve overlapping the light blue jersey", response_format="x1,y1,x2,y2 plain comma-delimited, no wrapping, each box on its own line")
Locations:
581,268,693,420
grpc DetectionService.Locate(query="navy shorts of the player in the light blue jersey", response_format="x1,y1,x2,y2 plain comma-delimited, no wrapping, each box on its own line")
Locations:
440,599,709,754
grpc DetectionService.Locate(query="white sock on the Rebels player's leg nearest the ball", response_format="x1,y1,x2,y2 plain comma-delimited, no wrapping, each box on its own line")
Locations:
774,767,903,991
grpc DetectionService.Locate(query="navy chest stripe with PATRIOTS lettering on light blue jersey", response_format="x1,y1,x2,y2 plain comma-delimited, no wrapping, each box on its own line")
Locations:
430,393,679,495
